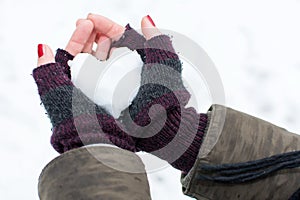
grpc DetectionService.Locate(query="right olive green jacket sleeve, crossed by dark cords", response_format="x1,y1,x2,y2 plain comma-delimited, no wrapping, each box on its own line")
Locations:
181,105,300,200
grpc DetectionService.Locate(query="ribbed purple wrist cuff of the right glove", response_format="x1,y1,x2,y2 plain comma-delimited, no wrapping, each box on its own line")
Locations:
136,108,207,172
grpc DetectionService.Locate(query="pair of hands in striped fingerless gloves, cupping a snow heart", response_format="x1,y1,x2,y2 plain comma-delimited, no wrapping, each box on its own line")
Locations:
33,14,207,172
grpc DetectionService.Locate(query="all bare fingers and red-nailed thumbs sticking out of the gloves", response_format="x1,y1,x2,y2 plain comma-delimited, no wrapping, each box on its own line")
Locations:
37,14,161,66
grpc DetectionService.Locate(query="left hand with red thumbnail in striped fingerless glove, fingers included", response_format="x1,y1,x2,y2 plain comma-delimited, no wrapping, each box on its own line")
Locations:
32,16,136,153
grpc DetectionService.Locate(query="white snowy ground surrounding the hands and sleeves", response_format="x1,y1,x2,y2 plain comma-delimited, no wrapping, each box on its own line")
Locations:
0,0,300,200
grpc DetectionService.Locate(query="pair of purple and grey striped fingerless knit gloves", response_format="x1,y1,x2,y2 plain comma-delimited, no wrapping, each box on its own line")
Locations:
33,25,208,173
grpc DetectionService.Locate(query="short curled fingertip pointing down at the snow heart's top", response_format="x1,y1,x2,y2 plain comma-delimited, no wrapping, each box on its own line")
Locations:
94,35,111,60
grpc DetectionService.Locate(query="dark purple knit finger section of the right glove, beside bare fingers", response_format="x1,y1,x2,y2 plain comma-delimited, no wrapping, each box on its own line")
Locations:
111,24,146,62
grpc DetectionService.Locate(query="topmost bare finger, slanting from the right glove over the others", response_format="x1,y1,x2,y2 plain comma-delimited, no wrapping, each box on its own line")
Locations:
88,14,125,41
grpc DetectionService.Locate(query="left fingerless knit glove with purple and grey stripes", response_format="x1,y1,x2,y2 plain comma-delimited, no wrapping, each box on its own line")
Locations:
33,49,136,153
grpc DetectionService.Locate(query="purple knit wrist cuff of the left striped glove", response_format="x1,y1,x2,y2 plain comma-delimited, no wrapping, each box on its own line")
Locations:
51,114,136,153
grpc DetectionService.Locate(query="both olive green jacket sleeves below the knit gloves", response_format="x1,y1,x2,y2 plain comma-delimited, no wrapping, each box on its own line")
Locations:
38,105,300,200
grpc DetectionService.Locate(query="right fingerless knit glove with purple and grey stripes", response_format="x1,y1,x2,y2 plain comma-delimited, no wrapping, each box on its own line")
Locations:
114,25,207,172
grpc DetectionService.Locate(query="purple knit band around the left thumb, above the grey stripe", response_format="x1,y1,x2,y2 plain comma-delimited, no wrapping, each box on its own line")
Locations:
32,63,72,96
